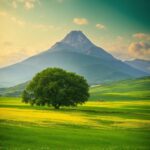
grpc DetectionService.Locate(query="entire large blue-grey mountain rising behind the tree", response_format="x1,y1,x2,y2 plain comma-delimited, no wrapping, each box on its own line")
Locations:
0,31,147,87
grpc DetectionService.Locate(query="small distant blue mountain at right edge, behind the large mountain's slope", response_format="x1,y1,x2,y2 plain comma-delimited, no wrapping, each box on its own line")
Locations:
125,59,150,74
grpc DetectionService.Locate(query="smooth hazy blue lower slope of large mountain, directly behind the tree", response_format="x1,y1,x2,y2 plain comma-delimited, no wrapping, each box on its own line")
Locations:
0,51,130,86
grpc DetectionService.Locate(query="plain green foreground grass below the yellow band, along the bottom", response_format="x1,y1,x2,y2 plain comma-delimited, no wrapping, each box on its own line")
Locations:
0,123,149,150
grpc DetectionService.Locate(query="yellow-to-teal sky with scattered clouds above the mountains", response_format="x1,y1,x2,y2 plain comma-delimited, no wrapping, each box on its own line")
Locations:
0,0,150,67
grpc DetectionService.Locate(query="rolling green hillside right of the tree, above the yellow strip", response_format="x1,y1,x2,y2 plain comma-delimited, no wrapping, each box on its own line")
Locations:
90,76,150,101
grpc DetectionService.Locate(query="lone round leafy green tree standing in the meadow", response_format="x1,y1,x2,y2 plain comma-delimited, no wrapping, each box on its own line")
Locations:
22,68,89,109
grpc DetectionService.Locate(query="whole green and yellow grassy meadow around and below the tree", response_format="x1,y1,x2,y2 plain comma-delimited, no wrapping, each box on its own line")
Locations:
0,78,150,150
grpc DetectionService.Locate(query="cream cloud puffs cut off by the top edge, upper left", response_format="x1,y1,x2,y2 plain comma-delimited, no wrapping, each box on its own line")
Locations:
12,0,40,10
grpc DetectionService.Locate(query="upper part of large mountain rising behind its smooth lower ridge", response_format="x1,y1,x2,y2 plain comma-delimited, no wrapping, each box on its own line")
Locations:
50,31,114,60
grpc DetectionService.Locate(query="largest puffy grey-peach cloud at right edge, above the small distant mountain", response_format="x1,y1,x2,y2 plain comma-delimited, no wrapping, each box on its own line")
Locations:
128,42,150,59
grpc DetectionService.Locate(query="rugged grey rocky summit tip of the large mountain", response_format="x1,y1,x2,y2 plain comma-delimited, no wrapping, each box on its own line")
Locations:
61,30,93,49
